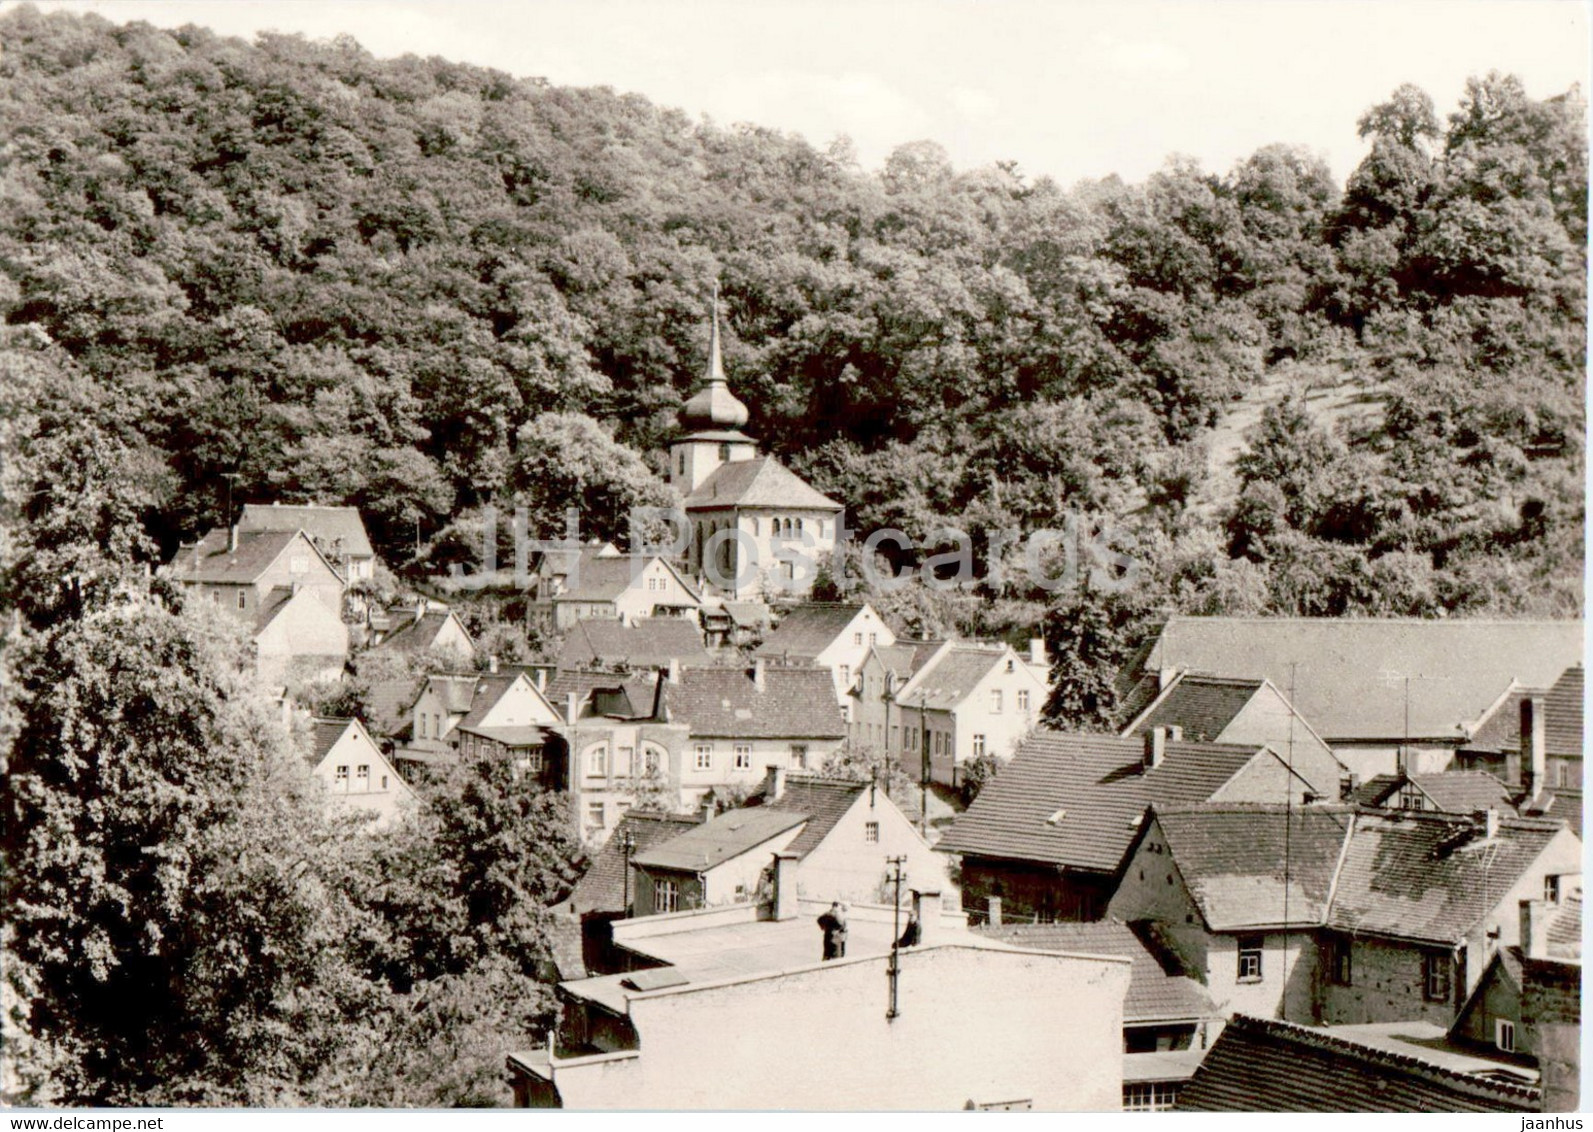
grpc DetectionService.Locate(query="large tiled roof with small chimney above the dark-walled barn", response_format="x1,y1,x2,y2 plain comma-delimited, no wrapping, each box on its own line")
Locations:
935,731,1258,872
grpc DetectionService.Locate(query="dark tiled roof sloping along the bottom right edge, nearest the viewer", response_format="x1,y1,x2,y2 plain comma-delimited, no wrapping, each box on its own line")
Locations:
1176,1014,1542,1113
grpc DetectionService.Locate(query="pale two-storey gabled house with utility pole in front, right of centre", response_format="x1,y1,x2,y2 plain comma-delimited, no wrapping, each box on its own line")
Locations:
884,642,1048,787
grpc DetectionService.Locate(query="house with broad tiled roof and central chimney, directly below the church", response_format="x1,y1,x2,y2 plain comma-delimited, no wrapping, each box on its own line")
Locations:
666,659,846,792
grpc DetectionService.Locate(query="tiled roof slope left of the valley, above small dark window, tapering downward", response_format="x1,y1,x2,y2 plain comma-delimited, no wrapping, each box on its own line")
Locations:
1157,806,1354,931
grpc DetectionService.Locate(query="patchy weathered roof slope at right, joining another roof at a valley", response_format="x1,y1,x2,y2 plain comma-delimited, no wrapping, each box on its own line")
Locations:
1327,810,1564,944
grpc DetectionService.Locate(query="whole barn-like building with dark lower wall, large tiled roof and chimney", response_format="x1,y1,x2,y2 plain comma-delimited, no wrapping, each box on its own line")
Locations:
935,729,1340,922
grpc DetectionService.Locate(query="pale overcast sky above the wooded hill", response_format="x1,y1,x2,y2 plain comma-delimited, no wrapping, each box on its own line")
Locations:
28,0,1588,183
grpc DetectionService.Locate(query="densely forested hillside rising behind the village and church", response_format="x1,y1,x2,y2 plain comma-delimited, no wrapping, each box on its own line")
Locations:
0,8,1587,627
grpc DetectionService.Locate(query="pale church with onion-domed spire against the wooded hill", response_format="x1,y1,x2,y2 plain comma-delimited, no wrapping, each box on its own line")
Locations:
669,298,844,600
